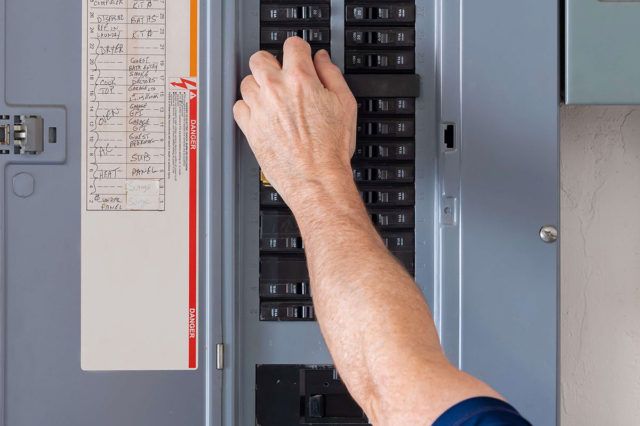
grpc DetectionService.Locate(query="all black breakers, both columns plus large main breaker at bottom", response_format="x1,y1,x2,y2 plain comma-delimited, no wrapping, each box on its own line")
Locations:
256,0,419,426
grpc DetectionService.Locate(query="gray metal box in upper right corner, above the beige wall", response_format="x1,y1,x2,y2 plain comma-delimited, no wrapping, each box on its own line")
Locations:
564,0,640,104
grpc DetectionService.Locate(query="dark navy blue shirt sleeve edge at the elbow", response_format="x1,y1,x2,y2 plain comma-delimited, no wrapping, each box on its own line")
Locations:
433,396,531,426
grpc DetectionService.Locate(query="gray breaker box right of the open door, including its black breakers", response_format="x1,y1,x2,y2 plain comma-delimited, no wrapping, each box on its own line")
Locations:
238,0,558,425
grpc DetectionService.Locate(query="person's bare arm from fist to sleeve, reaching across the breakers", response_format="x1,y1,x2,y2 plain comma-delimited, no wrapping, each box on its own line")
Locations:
234,37,497,426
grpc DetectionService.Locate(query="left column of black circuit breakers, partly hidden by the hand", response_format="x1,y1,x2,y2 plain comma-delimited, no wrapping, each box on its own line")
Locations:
259,0,331,321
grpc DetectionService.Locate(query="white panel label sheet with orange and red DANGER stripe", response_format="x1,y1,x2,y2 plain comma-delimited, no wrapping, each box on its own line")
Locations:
81,0,199,370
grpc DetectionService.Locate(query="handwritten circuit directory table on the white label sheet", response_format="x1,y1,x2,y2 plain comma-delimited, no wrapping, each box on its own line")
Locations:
86,0,167,210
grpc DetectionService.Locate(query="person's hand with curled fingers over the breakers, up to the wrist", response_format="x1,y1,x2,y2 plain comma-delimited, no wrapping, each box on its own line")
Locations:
233,37,357,213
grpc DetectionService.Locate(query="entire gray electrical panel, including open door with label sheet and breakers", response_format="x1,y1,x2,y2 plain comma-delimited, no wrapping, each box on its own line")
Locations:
0,0,559,426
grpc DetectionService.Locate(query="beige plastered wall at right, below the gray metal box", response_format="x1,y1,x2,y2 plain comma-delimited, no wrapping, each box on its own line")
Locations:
560,106,640,426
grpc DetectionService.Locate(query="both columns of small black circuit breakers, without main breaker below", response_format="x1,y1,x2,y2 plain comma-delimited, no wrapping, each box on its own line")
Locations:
259,0,419,321
